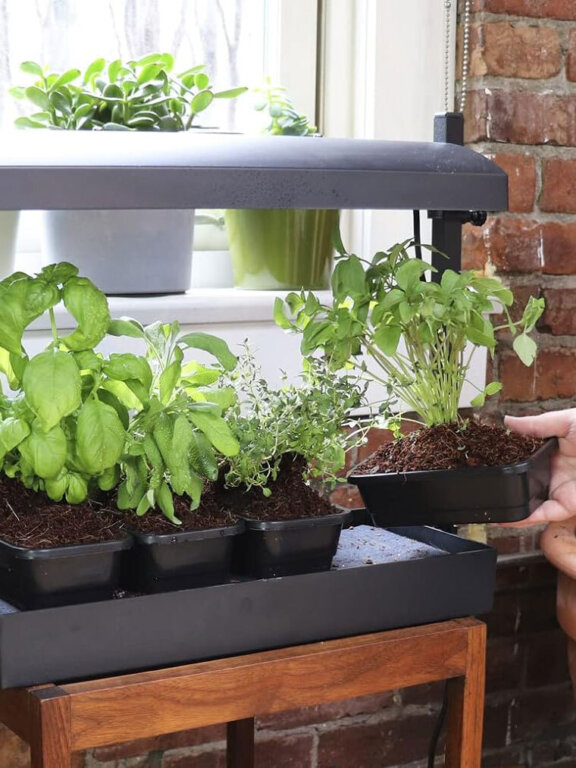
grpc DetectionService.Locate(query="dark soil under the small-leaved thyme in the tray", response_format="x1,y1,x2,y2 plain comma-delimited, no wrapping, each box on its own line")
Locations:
219,455,338,520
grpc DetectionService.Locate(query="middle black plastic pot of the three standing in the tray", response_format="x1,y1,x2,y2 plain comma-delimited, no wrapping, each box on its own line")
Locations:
122,522,244,593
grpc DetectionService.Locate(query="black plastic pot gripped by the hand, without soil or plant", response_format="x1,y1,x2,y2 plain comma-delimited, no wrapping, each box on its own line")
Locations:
348,438,558,526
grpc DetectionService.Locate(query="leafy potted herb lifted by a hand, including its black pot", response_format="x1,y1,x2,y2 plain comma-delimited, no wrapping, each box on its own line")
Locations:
276,241,553,525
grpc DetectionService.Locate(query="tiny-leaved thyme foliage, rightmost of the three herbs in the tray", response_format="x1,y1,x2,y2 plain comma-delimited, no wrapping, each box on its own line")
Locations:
222,348,364,495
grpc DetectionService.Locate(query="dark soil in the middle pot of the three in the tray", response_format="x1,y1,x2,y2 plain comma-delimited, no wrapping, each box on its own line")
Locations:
124,483,237,534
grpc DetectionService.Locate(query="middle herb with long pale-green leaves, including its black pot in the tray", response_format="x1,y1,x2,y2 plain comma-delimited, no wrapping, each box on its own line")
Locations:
109,318,244,592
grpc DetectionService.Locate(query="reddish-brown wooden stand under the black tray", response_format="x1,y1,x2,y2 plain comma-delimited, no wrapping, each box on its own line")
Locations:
0,619,486,768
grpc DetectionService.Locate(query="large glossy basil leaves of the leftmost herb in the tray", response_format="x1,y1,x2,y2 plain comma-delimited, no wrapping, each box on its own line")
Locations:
0,263,128,504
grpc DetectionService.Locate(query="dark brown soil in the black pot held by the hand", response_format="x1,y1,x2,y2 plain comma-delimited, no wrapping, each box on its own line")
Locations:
354,421,542,475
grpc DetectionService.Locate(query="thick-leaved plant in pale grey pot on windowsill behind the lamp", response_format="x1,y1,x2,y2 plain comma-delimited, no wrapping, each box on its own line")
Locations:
11,53,246,295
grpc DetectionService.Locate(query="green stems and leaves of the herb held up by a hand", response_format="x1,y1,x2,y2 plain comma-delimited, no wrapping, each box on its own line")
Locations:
275,237,544,426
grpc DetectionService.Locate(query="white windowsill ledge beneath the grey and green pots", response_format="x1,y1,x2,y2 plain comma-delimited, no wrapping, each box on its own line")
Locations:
30,288,332,331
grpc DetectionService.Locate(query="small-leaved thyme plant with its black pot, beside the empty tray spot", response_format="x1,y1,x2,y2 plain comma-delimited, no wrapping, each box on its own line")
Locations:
220,351,363,577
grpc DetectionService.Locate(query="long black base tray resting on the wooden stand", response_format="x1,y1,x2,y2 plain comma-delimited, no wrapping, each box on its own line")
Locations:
0,510,496,688
